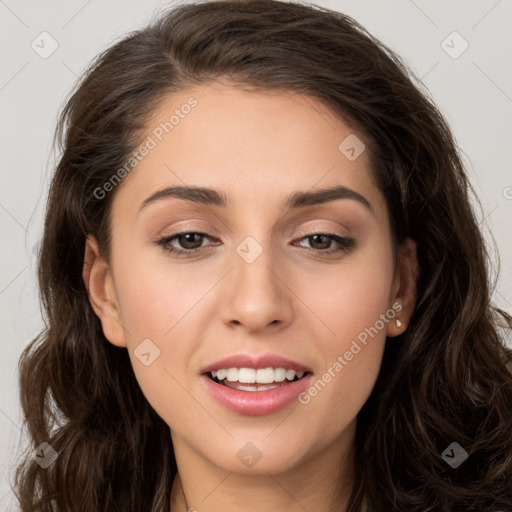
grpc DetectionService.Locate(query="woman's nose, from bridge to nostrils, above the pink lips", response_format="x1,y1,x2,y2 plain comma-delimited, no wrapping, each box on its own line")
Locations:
220,241,293,333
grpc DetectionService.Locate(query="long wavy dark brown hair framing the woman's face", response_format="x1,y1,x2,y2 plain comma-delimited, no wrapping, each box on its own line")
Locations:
16,0,512,512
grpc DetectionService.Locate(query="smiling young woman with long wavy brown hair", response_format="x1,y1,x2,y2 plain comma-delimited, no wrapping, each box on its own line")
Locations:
17,0,512,512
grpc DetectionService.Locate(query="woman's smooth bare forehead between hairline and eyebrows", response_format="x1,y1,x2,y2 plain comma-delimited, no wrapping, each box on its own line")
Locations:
110,82,383,220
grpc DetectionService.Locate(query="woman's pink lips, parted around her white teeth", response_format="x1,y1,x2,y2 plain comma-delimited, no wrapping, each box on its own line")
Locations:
201,354,313,416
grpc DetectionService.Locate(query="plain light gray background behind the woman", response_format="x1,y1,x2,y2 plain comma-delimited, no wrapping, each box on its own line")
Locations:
0,0,512,510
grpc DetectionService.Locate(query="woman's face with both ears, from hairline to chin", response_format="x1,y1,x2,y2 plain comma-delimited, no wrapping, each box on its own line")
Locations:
84,83,414,474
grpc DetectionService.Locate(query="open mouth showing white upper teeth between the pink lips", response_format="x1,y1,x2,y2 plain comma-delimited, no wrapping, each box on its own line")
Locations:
207,368,310,391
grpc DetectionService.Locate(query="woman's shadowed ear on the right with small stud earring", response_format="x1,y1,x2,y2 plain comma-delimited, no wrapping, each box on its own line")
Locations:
386,238,419,337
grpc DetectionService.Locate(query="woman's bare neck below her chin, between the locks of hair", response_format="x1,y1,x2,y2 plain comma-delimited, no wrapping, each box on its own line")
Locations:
171,423,355,512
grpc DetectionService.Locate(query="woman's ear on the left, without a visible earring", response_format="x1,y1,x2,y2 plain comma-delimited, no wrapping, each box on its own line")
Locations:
82,235,126,347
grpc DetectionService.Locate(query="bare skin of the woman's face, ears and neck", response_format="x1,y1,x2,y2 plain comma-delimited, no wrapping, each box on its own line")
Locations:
83,82,417,512
